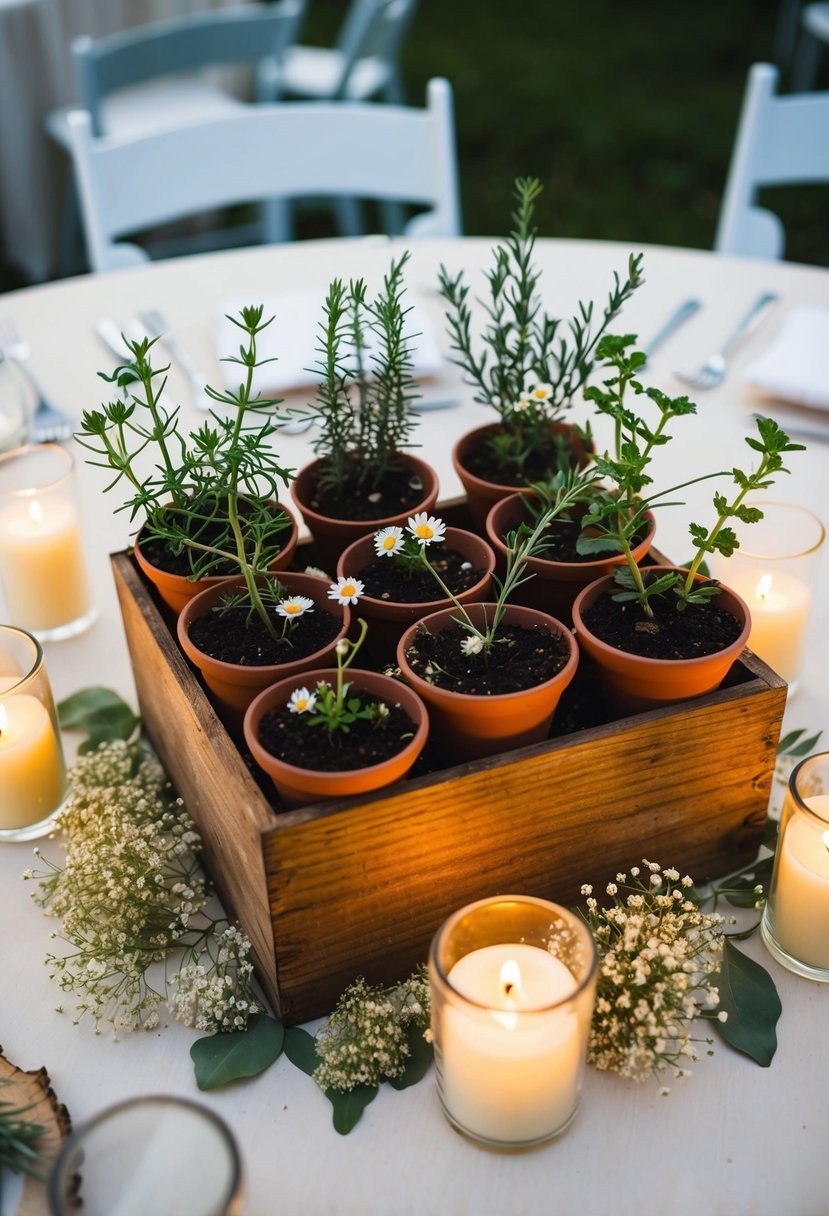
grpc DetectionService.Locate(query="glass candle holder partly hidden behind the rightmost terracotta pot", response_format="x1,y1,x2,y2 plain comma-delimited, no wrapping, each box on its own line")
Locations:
711,502,827,692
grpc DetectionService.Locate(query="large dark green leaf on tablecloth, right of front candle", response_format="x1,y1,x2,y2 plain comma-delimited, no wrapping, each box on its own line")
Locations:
712,939,783,1068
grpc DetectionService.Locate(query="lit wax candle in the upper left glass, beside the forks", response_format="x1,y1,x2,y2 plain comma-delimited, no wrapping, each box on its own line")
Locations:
0,496,90,631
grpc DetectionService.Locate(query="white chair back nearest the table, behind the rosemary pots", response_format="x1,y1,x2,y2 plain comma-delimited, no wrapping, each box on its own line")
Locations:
68,79,461,271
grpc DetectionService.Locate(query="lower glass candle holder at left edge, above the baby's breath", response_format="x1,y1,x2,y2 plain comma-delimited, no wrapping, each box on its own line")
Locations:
0,625,67,841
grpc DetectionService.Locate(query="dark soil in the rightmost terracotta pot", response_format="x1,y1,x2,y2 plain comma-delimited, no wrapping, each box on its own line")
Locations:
582,593,743,659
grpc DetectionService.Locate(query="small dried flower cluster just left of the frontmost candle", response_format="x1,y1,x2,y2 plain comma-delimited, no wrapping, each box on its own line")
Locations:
314,968,429,1090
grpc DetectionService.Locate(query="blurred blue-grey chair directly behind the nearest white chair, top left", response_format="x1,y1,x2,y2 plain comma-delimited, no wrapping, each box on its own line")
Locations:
46,0,308,268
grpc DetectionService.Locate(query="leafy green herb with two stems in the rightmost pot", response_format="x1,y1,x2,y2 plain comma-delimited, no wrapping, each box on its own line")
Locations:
577,334,803,617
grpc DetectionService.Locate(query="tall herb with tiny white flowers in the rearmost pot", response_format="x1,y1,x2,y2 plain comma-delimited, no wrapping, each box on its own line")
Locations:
439,178,643,480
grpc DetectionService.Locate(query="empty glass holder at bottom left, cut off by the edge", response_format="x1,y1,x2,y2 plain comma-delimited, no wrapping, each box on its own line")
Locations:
47,1096,242,1216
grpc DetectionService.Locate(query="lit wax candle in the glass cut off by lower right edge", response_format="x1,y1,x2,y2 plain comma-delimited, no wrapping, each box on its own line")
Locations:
774,794,829,969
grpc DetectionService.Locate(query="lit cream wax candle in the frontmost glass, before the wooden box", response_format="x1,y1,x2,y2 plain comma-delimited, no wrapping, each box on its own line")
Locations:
439,944,583,1144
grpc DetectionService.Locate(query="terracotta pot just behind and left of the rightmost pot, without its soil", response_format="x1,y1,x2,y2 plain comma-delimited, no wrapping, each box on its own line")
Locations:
486,490,656,625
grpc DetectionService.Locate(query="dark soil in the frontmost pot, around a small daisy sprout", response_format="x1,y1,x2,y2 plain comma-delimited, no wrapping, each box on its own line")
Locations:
259,700,415,772
